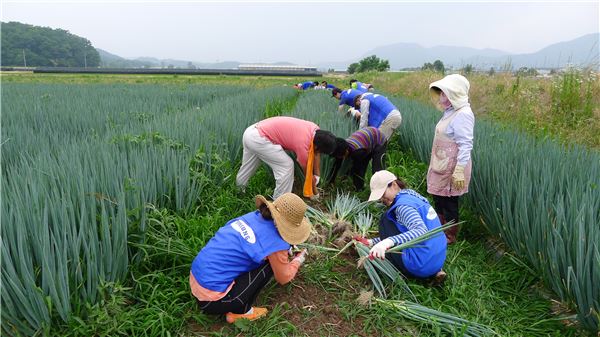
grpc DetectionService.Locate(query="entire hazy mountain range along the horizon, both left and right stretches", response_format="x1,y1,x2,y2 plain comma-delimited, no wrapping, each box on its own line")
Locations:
97,33,600,70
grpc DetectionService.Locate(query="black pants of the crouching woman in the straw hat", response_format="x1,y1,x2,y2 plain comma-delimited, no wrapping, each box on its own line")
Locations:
198,262,273,315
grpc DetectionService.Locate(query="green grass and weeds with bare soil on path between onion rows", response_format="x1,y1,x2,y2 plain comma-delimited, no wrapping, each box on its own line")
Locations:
3,75,583,336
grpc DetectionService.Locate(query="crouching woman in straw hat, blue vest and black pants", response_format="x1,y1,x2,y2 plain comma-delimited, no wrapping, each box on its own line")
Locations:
190,193,311,323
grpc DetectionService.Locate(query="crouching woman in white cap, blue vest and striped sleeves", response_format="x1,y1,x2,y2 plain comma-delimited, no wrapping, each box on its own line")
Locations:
354,170,447,284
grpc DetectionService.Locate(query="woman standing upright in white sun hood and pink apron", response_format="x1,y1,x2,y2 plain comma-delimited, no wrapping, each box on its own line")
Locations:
427,74,475,244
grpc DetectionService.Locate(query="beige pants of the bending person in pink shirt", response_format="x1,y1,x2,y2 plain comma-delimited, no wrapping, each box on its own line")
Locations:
235,124,294,199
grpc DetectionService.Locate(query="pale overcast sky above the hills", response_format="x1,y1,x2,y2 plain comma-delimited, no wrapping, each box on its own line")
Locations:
1,0,599,64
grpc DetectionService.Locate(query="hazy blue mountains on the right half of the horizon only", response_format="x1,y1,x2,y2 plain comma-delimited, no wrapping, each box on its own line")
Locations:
317,33,600,69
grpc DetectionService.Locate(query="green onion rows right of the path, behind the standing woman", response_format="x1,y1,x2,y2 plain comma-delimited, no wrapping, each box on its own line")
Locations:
386,94,600,329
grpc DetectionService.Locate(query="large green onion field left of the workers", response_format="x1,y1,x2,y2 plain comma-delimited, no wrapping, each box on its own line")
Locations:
1,85,295,335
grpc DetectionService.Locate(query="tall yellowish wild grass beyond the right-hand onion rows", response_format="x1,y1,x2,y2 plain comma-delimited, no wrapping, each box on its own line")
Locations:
357,69,600,149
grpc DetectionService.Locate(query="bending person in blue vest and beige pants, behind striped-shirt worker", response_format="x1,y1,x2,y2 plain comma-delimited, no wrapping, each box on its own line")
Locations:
354,93,402,140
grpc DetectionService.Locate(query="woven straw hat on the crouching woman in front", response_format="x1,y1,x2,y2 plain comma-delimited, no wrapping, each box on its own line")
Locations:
255,193,311,245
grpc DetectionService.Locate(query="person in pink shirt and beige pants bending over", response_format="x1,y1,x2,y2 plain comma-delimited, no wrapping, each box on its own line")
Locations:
236,116,336,198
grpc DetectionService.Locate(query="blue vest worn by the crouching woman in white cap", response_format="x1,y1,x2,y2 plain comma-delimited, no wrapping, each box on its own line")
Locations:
386,192,447,277
